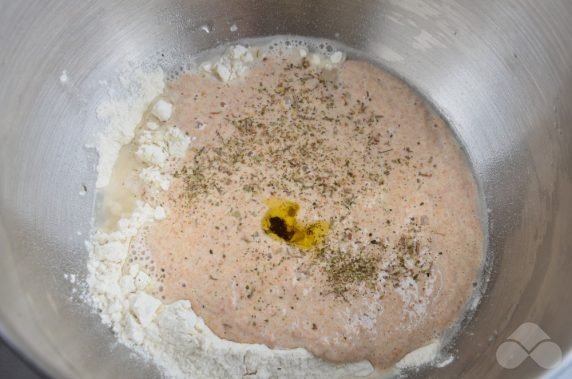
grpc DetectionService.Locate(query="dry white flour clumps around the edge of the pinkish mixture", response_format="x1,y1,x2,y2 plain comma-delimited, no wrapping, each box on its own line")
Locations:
86,46,438,378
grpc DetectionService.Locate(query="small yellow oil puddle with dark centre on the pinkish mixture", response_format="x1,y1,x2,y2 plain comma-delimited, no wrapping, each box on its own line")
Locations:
262,197,330,249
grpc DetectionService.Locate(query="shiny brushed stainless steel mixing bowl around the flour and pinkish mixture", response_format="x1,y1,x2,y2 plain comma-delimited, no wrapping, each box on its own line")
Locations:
0,0,572,378
